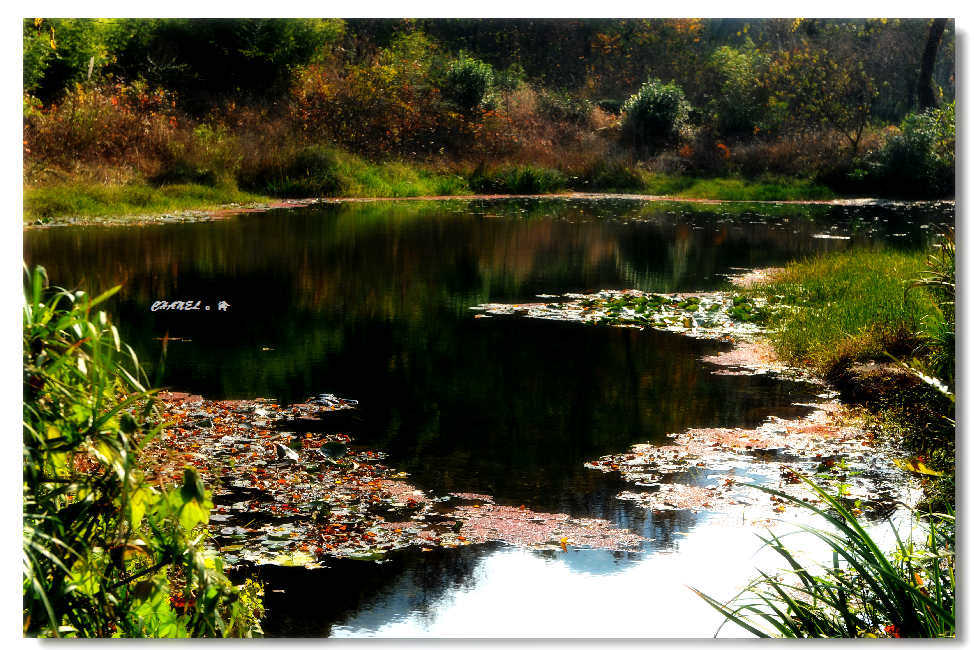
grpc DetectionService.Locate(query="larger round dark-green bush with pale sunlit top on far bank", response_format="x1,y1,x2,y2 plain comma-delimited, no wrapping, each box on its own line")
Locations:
622,79,690,149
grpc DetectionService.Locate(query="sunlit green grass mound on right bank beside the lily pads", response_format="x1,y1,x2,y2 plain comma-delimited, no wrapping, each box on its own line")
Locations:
756,249,939,376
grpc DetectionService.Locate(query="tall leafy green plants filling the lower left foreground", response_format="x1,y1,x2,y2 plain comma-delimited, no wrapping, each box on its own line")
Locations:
23,267,260,637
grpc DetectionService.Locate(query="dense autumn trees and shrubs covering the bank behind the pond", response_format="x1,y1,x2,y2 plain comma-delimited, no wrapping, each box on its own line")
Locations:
24,18,955,201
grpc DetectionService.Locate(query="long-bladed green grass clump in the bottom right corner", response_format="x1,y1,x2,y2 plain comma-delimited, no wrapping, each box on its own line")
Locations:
694,479,956,639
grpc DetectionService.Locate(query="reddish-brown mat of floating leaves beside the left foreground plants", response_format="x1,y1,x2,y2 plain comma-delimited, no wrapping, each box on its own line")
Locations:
143,393,643,568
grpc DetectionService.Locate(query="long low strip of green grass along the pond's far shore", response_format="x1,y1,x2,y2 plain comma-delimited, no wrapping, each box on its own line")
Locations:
24,160,835,223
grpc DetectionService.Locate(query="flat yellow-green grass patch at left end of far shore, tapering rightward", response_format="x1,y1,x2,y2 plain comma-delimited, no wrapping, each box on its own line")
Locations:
24,182,267,221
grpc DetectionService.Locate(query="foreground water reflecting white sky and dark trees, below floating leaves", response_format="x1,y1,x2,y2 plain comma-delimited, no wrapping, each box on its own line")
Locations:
263,513,774,638
